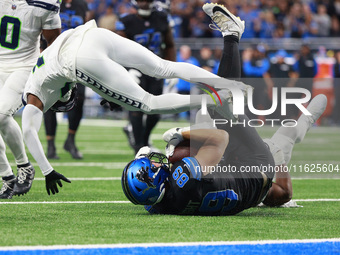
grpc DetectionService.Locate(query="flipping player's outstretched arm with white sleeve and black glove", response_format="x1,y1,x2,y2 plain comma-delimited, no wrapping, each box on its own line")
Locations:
22,94,71,195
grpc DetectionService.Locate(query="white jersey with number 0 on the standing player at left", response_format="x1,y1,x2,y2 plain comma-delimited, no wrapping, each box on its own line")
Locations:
0,0,61,71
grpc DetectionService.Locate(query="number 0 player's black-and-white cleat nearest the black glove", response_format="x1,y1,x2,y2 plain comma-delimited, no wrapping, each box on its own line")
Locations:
13,162,35,196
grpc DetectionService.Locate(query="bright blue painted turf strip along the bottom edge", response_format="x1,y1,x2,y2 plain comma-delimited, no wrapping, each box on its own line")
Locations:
0,241,340,255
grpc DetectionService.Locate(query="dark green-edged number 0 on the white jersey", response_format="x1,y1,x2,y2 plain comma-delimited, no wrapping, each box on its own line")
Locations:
0,16,21,50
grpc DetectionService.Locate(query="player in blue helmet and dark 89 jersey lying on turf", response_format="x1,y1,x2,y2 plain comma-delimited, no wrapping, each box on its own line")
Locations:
121,3,327,215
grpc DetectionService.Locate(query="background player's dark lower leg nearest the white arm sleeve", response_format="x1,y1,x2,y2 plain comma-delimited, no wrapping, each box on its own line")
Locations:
44,110,59,159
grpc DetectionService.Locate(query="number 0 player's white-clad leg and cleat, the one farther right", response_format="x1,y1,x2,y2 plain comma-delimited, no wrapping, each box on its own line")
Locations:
0,70,35,195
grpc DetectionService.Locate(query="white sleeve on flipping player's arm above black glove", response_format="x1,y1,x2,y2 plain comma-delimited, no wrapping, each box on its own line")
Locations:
22,104,53,176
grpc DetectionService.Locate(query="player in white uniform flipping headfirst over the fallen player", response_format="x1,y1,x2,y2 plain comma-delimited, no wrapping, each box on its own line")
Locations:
22,21,249,194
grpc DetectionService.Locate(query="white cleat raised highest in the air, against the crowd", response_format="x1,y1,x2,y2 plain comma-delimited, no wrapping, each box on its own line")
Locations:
202,3,245,40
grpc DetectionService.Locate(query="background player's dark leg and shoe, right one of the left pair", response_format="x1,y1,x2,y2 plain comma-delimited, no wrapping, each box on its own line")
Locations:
64,84,85,159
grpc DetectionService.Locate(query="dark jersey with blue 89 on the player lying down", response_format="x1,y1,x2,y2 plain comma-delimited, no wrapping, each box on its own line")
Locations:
145,157,270,215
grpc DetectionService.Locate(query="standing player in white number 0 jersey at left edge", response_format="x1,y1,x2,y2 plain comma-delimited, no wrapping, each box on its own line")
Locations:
0,0,61,199
